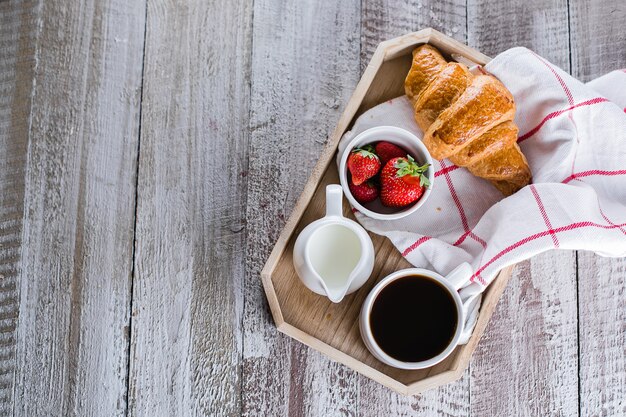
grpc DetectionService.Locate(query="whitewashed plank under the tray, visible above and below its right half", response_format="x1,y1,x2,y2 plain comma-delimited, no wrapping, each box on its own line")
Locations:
358,0,470,417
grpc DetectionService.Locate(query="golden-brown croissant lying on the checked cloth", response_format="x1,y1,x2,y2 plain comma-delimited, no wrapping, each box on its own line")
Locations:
404,45,531,196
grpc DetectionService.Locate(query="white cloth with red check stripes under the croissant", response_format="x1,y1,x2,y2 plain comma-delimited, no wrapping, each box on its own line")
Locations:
339,48,626,338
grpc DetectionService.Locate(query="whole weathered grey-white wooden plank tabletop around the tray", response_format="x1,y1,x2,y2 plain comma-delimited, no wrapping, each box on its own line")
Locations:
0,0,626,417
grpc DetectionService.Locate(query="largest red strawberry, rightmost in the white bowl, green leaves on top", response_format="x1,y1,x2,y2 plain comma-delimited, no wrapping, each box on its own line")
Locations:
380,155,430,207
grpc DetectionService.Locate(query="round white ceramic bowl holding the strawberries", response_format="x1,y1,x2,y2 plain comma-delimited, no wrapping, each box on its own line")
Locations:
339,126,435,220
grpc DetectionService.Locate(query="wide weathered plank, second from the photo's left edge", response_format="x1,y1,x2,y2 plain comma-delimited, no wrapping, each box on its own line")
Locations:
6,0,144,416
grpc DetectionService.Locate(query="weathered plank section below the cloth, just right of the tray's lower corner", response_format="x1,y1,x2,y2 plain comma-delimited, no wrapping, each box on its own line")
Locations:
470,251,578,416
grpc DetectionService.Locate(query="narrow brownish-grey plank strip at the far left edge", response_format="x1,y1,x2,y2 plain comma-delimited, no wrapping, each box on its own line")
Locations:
0,2,37,415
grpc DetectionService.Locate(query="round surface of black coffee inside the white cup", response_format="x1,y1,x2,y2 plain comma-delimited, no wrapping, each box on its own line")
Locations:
370,275,457,362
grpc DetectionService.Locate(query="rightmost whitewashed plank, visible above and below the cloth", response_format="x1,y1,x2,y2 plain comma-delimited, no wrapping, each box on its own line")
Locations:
569,0,626,416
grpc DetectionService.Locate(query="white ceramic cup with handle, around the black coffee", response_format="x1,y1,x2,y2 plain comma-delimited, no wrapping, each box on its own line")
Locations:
359,263,482,369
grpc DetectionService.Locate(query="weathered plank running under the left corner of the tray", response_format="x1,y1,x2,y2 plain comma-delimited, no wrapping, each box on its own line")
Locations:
242,0,360,416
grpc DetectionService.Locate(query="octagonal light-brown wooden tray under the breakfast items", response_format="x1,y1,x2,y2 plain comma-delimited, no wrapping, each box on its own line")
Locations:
261,29,513,395
